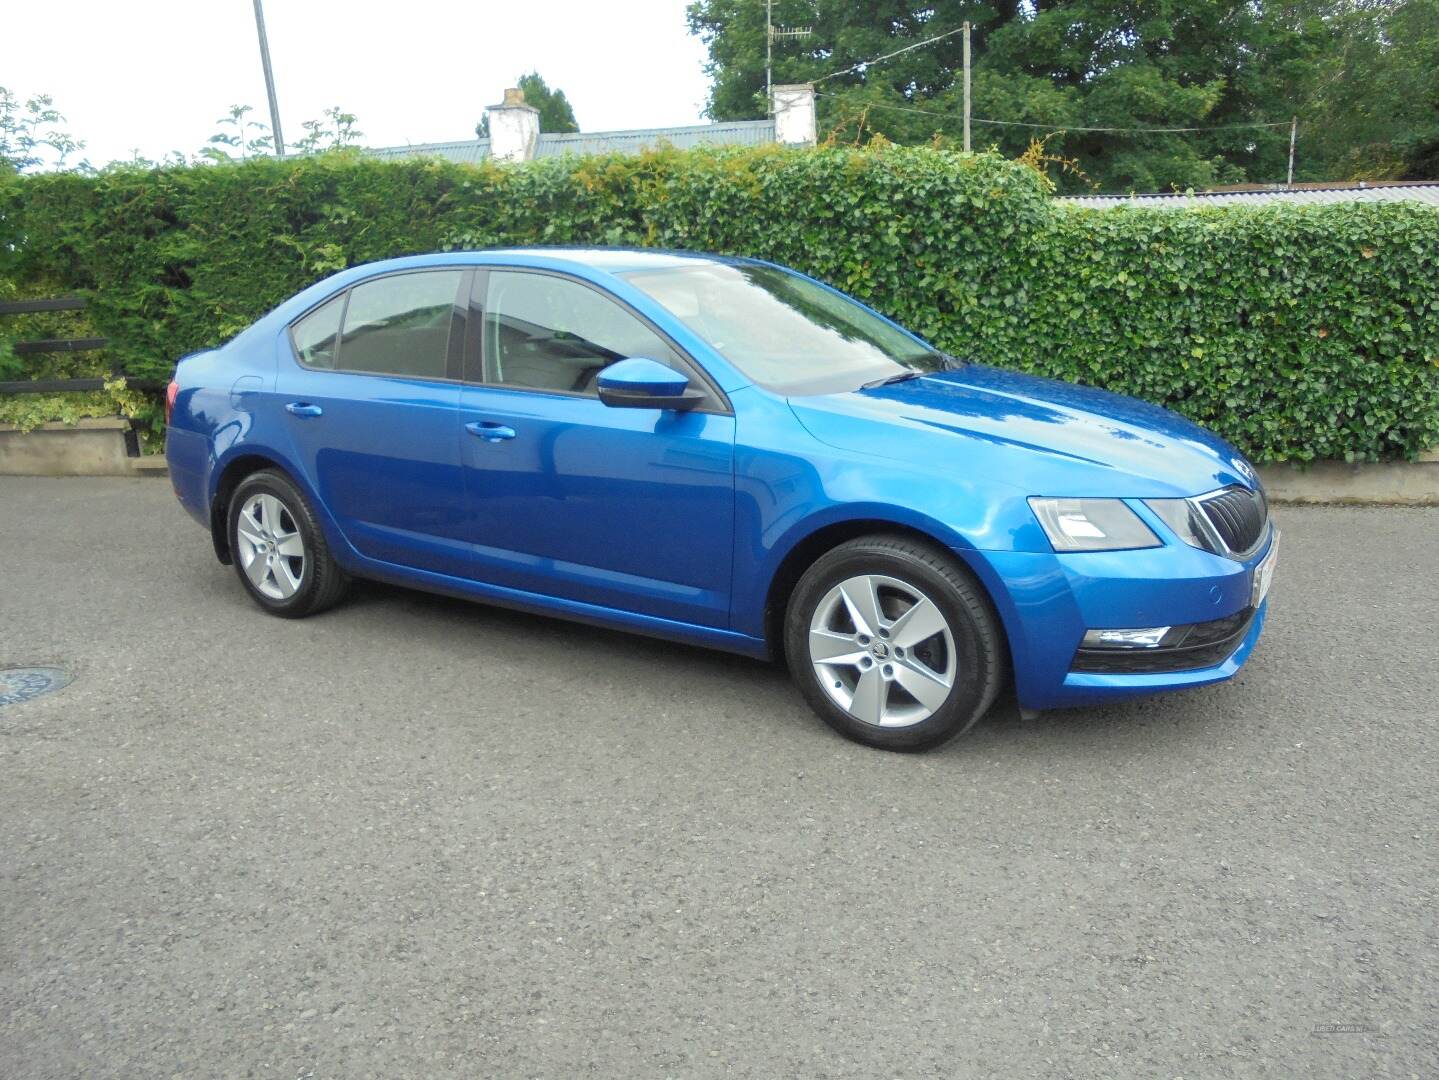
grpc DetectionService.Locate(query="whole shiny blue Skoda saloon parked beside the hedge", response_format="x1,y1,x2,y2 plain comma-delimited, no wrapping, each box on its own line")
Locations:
165,249,1279,749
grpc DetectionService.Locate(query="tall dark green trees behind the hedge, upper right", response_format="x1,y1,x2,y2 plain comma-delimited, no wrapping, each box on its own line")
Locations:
688,0,1439,191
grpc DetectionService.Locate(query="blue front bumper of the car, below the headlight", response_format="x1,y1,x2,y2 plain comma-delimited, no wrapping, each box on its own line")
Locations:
957,522,1276,709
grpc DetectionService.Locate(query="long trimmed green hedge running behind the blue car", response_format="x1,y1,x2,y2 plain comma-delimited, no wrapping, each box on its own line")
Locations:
0,147,1439,460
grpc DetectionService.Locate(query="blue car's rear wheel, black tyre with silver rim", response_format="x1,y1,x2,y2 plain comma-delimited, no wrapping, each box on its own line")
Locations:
227,469,348,618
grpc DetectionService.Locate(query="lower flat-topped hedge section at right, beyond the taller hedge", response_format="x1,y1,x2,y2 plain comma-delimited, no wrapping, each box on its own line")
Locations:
971,203,1439,462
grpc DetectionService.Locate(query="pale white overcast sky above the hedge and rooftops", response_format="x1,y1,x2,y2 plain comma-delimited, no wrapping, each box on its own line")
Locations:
0,0,708,165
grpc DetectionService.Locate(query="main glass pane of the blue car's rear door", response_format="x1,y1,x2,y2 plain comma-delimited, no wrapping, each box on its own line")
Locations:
338,270,465,378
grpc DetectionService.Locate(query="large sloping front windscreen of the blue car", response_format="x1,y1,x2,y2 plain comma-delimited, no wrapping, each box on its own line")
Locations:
623,263,954,394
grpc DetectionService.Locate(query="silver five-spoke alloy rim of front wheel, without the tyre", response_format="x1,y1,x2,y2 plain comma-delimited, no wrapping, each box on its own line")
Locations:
809,574,958,728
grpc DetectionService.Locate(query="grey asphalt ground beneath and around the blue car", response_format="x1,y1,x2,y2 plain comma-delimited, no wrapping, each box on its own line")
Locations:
0,479,1439,1080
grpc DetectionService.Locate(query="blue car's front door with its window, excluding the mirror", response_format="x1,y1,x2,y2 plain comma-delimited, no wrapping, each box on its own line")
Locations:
460,270,734,628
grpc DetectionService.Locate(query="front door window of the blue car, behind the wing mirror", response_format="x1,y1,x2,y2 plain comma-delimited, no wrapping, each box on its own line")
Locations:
484,270,684,394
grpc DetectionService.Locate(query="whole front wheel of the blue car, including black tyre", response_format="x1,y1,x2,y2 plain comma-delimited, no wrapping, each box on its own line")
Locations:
784,535,1006,751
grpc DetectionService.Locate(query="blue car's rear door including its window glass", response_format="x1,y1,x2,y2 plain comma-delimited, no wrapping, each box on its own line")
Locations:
276,267,473,575
